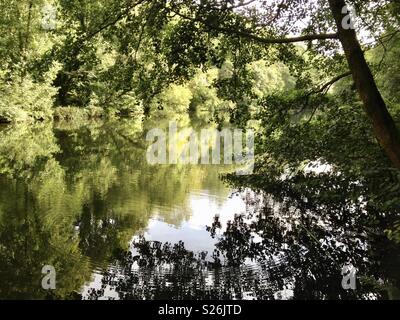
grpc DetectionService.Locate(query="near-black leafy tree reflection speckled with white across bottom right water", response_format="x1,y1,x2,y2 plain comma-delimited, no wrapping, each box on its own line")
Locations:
86,185,400,299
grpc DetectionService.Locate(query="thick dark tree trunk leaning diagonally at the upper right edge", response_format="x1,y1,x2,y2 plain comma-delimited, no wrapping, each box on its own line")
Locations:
329,0,400,169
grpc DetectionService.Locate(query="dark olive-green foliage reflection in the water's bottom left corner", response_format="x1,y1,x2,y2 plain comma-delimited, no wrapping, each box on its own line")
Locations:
0,180,90,299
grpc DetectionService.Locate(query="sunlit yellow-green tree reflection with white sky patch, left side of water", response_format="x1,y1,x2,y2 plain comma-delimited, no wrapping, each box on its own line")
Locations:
0,118,238,299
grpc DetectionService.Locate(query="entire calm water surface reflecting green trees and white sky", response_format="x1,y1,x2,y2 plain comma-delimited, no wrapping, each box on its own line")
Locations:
0,118,400,299
